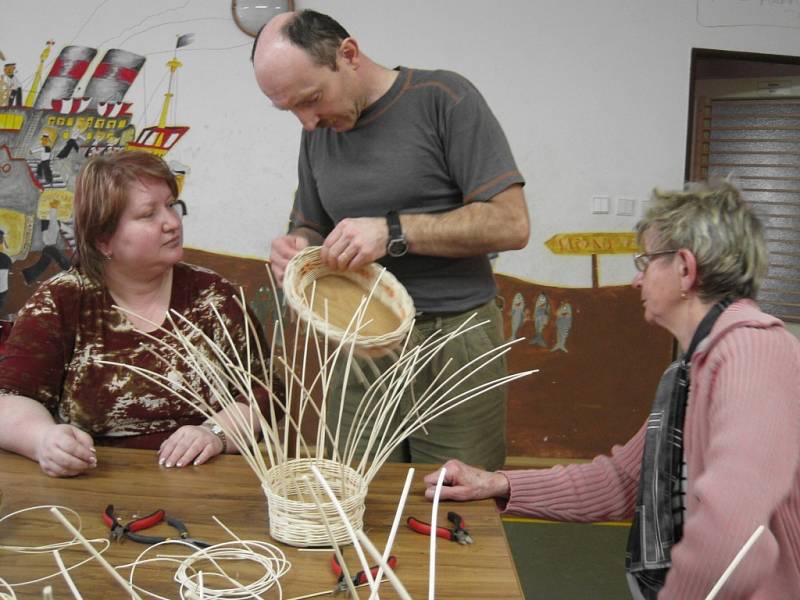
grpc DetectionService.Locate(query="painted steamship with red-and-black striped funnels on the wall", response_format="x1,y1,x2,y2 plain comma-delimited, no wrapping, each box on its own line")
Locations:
0,41,189,261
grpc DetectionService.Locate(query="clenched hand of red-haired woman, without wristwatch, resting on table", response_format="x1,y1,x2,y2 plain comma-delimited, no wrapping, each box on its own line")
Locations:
36,424,97,477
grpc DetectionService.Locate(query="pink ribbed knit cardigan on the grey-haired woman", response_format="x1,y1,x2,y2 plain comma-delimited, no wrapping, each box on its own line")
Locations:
504,300,800,600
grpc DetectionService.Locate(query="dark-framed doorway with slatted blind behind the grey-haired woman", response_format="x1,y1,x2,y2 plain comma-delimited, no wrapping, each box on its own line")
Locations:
685,48,800,323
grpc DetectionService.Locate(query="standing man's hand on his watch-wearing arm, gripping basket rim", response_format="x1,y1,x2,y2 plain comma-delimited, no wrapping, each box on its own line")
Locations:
320,217,389,271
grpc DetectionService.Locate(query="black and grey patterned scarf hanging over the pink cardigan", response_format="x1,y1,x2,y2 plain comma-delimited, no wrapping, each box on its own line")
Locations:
625,299,731,600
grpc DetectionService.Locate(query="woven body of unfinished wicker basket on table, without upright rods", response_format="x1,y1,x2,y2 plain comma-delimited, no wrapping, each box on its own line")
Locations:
262,458,367,547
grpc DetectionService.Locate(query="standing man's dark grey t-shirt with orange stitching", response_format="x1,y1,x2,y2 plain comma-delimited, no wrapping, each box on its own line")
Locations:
292,67,524,313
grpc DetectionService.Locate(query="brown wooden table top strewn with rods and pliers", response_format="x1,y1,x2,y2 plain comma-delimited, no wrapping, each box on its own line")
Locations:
0,448,523,600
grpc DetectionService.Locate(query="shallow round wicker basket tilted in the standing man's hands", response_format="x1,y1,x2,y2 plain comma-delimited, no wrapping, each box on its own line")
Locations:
283,246,415,354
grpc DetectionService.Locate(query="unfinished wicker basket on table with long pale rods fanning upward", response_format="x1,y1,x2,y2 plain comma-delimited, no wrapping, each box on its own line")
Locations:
100,269,534,546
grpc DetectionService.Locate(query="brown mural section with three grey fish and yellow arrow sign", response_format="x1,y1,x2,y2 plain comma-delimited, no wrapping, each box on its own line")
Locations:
497,231,672,459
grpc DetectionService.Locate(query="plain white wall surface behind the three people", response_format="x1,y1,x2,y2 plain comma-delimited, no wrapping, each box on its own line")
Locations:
0,0,800,287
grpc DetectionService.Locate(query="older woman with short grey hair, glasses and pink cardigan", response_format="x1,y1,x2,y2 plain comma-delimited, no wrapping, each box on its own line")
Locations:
426,183,800,600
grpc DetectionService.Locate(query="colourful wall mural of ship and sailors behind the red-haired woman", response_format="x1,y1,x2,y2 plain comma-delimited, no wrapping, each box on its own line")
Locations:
0,33,193,317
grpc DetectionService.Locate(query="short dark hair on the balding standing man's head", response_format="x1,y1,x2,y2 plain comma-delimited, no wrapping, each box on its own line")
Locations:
250,10,350,71
